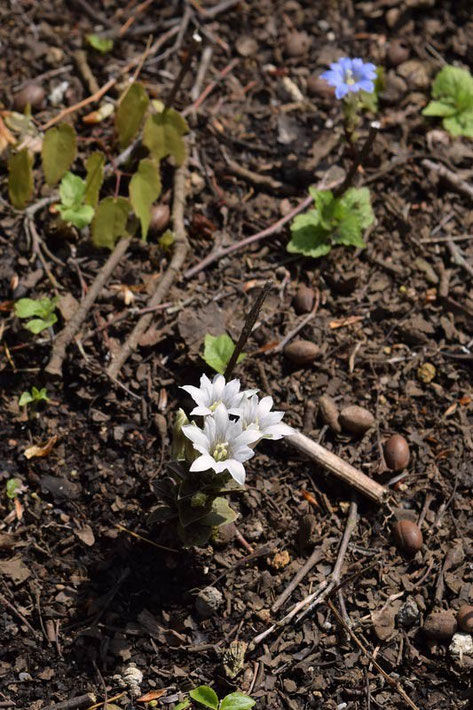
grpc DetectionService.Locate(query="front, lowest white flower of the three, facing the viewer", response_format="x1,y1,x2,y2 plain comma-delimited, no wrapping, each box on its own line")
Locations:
182,404,260,485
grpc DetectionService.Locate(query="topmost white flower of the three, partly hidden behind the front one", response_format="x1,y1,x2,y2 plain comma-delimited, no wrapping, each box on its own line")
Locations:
181,375,257,417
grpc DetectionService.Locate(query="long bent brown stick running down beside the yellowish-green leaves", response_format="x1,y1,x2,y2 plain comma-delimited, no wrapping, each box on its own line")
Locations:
107,154,189,379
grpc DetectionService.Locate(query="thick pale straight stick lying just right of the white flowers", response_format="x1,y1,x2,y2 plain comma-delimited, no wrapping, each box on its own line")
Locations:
285,432,390,504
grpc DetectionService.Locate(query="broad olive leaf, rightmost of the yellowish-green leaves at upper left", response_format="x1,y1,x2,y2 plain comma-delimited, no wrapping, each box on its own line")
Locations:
143,108,189,165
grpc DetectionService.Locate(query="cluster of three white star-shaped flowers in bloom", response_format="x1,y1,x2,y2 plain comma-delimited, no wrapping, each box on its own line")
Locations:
182,375,294,485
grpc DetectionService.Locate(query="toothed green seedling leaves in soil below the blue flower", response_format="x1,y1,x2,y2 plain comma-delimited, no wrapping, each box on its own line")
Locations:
287,187,374,258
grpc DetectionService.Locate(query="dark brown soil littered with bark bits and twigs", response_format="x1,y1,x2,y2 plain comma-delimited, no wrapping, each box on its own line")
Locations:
0,0,473,710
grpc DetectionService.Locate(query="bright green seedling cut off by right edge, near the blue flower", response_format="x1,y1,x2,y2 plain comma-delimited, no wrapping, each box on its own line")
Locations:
422,65,473,138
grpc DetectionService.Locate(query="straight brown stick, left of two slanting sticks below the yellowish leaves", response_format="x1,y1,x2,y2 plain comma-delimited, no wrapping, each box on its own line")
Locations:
46,237,131,377
